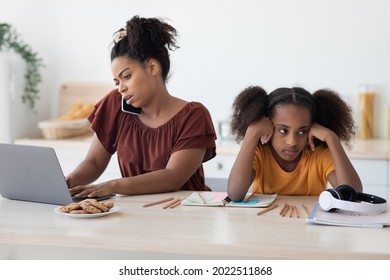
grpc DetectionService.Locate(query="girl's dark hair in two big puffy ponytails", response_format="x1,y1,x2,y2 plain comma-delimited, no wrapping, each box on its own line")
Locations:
231,86,356,146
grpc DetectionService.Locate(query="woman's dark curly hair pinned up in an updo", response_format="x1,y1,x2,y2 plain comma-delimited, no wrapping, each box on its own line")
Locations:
111,16,178,81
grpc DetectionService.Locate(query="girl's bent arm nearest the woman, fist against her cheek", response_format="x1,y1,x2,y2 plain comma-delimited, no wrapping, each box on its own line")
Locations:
228,117,274,201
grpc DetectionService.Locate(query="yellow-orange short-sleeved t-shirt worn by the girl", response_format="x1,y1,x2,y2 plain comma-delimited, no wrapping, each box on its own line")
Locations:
252,144,334,195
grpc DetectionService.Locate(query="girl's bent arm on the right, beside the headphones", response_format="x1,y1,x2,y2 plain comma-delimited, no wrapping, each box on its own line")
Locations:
308,123,363,192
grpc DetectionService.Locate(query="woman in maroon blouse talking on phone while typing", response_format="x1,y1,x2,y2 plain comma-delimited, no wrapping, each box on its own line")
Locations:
67,16,216,197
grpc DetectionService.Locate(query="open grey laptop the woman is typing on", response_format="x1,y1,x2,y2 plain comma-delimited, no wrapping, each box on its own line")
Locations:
0,143,111,205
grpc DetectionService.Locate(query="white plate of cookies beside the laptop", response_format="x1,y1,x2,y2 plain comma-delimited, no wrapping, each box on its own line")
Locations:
54,198,119,219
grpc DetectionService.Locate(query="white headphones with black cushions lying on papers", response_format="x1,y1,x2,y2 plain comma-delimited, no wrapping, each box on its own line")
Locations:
319,185,387,214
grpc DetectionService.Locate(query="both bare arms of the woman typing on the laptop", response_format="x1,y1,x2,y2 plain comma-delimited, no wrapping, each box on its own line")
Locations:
70,135,206,197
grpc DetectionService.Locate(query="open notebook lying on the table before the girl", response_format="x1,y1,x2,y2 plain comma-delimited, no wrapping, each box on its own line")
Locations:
181,192,277,208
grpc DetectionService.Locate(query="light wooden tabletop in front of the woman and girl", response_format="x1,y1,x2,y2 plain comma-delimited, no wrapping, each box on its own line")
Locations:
0,192,390,260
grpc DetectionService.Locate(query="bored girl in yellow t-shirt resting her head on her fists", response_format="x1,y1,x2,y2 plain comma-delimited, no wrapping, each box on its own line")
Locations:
228,86,362,201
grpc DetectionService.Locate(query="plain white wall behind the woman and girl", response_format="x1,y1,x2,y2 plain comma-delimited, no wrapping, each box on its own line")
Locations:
0,0,390,138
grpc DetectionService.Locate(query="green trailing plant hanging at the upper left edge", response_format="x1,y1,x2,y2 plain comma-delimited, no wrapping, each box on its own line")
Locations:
0,23,44,110
